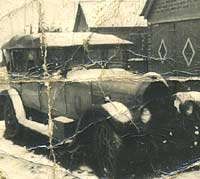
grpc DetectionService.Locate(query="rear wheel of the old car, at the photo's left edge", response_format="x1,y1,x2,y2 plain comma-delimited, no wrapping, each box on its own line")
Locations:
4,98,20,139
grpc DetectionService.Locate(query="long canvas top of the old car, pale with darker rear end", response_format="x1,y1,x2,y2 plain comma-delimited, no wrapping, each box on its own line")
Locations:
2,32,133,49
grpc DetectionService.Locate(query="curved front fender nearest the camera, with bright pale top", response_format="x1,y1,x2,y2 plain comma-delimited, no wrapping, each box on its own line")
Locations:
76,102,136,135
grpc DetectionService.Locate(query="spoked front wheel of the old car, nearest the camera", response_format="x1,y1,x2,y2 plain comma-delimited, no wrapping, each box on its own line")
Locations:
93,122,121,177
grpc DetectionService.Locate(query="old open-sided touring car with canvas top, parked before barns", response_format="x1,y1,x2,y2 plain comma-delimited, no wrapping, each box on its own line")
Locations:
0,33,200,175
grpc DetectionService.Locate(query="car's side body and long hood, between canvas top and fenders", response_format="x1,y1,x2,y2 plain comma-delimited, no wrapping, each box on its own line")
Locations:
6,69,167,124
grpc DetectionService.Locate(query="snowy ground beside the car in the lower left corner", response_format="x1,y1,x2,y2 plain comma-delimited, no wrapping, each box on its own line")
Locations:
0,121,97,179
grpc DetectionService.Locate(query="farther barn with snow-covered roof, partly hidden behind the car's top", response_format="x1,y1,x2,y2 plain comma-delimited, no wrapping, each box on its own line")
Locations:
73,0,148,72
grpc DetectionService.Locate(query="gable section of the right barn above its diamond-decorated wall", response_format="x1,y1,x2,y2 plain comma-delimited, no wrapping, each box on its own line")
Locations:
148,0,200,23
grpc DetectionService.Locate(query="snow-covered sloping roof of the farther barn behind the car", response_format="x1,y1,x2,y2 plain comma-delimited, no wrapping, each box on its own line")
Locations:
79,0,147,27
